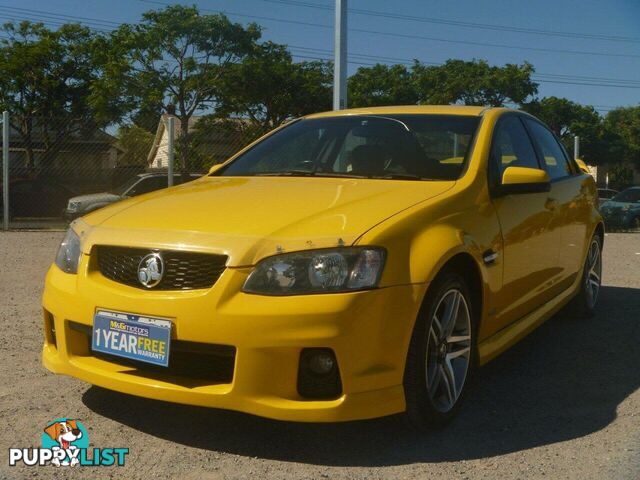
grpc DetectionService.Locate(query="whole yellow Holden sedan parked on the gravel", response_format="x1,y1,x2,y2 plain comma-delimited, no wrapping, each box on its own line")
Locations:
43,106,604,426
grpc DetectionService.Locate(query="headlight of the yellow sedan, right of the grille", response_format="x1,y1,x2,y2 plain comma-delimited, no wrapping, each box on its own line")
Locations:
243,247,385,295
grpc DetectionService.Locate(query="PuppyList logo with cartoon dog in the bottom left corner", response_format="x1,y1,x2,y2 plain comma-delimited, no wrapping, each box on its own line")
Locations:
9,418,129,467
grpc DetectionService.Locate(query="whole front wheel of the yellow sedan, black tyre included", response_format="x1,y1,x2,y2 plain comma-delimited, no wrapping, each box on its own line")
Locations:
404,271,476,428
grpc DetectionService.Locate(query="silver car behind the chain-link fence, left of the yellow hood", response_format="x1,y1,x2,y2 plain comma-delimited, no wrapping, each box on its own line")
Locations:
64,173,202,220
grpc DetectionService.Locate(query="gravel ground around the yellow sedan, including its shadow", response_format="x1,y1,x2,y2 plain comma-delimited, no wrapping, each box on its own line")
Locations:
0,232,640,480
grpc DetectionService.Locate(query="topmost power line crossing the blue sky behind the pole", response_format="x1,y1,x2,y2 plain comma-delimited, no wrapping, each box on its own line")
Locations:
262,0,640,43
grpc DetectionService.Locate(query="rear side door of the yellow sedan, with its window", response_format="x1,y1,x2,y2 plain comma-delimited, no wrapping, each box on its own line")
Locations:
524,117,591,286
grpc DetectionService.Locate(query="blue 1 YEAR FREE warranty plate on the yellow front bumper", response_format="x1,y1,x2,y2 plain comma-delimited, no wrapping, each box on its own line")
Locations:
91,310,171,367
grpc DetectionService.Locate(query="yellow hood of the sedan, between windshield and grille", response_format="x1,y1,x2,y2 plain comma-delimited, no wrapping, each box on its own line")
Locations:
75,177,455,266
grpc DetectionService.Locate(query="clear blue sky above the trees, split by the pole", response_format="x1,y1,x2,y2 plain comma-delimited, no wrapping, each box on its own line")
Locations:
0,0,640,114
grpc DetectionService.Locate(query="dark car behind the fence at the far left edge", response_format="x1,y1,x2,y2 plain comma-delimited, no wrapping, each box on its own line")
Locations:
0,177,75,219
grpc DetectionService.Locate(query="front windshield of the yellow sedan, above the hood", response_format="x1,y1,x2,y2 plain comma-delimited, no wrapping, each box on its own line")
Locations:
214,115,480,180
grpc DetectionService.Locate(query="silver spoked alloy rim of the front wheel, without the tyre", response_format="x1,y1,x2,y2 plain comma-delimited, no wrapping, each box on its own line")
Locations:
425,289,471,413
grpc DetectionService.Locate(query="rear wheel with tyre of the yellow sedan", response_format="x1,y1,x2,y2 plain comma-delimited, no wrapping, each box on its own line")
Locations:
569,233,602,318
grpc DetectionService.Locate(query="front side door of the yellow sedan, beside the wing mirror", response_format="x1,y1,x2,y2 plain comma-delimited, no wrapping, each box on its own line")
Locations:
488,114,560,330
